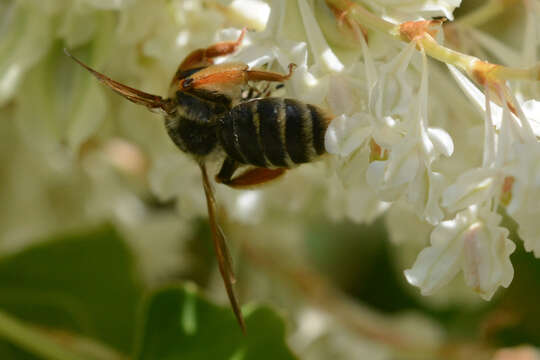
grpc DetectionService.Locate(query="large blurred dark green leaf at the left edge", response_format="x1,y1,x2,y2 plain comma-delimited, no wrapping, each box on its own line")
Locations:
0,226,142,353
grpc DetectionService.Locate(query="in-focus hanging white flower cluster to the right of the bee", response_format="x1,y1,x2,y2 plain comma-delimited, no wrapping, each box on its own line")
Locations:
316,2,540,300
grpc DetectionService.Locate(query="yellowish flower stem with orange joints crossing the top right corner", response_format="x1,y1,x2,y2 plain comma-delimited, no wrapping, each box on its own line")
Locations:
326,0,540,81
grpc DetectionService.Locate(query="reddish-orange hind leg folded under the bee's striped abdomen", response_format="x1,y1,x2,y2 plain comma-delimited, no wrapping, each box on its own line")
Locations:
216,158,287,189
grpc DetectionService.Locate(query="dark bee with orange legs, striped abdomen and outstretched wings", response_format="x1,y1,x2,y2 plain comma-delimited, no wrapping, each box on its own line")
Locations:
64,29,332,332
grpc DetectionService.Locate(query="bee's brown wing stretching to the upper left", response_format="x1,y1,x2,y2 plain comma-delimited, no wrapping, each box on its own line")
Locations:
64,49,174,114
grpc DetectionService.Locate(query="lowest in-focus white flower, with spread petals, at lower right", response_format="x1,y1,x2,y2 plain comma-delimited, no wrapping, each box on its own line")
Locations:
405,206,515,300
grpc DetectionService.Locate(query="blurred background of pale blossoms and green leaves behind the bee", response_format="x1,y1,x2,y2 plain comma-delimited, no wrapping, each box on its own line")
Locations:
0,0,540,360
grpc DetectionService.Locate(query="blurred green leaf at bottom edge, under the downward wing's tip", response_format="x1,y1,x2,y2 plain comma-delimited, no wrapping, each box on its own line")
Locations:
134,286,296,360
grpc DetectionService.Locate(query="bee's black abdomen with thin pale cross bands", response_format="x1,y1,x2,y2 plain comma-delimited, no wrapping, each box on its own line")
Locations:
218,98,331,168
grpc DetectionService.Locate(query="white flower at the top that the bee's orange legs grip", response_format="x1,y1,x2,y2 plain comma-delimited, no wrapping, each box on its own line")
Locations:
220,0,344,105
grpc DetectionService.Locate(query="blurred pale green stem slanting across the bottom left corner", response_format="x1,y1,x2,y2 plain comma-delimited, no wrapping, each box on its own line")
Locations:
0,311,88,360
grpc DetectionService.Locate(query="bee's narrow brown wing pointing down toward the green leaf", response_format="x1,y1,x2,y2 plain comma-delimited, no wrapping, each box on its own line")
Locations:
199,163,246,333
